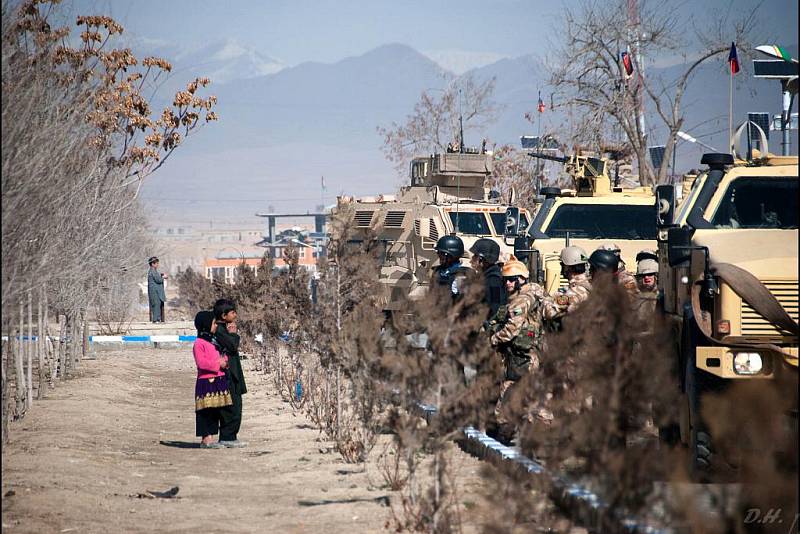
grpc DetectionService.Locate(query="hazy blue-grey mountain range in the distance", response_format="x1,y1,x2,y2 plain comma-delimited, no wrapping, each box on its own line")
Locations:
143,40,796,224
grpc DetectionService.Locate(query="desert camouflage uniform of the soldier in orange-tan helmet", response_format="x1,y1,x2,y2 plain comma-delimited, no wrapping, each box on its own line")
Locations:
490,283,546,432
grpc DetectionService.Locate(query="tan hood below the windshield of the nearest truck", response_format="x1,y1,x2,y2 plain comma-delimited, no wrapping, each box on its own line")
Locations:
692,229,798,280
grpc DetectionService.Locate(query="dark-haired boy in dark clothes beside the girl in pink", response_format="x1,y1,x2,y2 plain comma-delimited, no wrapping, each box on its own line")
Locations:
214,299,247,448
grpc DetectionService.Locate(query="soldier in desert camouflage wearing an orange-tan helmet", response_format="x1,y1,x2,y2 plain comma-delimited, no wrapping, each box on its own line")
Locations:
490,256,545,442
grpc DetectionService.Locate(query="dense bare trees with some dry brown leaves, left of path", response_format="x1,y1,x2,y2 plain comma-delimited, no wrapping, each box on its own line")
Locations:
0,0,216,434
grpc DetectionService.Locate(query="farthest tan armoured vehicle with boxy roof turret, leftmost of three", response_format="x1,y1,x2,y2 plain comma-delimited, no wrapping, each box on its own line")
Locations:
336,148,530,312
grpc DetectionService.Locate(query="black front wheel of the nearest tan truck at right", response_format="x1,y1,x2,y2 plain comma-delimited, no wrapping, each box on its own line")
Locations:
686,351,714,482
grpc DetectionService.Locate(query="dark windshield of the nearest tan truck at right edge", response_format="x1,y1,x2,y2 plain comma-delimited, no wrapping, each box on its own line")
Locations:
711,176,798,229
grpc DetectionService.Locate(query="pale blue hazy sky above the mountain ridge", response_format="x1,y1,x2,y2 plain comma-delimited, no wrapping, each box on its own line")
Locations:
74,0,798,69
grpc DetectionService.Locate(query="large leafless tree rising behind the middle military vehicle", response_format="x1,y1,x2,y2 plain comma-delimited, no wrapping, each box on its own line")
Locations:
550,0,758,185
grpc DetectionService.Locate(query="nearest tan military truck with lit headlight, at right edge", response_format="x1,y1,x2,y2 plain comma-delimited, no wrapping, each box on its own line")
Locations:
656,150,798,478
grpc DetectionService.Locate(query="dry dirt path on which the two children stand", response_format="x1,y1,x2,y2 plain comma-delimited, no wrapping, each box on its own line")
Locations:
2,347,488,533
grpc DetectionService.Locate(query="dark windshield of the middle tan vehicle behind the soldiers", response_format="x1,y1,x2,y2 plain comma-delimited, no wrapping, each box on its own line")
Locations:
544,204,656,239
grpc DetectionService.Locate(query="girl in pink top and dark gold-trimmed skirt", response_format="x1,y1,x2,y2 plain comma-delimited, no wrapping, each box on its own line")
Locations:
192,311,233,449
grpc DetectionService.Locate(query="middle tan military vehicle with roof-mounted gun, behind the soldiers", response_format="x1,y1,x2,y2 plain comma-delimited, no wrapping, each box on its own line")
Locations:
506,153,656,294
